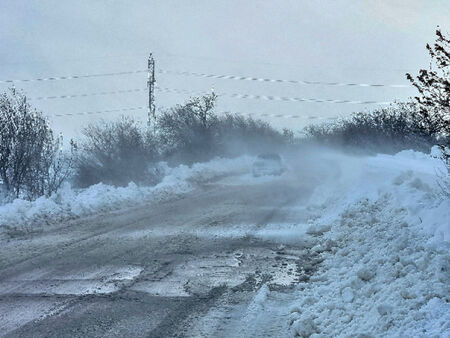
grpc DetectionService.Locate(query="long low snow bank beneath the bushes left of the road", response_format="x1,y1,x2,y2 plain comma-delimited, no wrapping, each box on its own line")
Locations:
0,157,252,235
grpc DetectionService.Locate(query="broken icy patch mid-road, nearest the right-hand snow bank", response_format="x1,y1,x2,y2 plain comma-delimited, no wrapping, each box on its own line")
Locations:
130,248,306,297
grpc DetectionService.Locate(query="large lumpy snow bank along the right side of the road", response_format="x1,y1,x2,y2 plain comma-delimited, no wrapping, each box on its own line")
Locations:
289,149,450,337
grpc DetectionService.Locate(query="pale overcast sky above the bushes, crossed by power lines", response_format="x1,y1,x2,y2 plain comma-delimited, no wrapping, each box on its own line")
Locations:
0,0,450,137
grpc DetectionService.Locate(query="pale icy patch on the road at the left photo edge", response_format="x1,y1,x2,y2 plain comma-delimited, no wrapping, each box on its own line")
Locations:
0,266,143,296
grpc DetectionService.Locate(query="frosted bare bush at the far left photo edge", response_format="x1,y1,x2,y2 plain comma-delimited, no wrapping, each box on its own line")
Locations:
0,89,71,199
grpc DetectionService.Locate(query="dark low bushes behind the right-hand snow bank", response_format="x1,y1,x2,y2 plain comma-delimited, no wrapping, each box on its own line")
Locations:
305,103,436,153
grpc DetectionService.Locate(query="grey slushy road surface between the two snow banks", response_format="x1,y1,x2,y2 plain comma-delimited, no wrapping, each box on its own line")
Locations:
0,173,320,337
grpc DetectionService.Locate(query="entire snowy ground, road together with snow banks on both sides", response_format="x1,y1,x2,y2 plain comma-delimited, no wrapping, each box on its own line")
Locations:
0,149,450,338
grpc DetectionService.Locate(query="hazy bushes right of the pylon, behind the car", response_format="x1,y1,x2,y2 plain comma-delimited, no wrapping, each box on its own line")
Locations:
156,94,293,163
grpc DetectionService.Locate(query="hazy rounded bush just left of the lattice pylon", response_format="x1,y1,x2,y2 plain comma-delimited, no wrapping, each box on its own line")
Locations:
75,117,157,187
